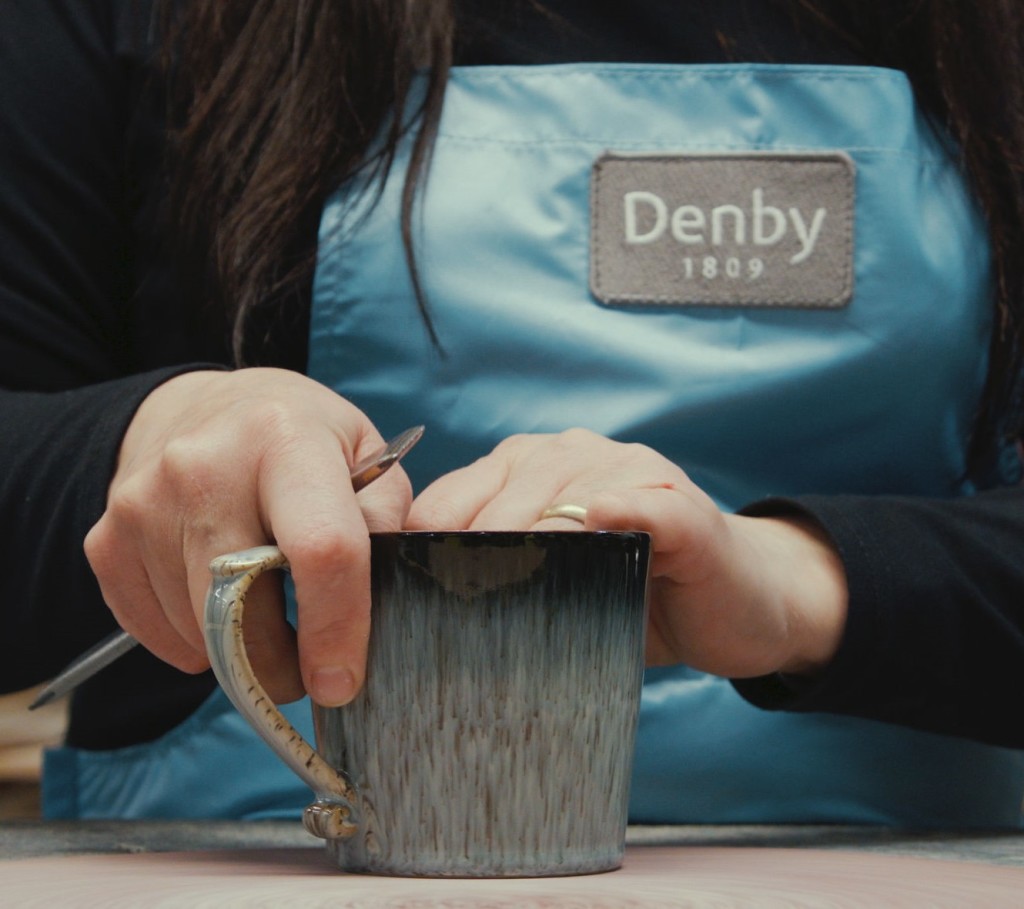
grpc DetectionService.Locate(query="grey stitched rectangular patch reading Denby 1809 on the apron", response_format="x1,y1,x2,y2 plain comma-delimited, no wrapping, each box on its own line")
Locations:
590,152,854,308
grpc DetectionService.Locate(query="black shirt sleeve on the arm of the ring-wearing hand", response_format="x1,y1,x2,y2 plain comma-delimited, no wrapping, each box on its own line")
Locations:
733,487,1024,748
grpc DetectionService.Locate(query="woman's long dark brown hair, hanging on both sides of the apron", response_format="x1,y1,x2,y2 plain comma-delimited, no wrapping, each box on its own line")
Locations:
165,0,1024,466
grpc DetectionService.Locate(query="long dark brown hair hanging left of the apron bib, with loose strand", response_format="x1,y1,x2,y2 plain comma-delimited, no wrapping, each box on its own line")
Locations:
162,0,453,364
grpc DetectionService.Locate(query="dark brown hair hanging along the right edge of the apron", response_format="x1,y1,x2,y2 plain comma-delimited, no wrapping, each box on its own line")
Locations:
792,0,1024,470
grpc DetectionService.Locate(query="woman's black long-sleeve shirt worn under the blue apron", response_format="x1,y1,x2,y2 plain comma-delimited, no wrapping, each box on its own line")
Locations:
0,0,1024,748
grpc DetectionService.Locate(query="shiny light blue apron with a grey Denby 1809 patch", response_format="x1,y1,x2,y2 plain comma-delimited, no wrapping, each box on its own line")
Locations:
45,64,1024,826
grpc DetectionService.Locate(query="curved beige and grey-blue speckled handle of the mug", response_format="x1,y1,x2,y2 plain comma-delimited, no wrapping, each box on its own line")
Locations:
204,546,358,839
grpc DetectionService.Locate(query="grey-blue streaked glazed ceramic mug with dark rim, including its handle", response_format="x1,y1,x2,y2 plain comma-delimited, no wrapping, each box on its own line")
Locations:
206,531,649,877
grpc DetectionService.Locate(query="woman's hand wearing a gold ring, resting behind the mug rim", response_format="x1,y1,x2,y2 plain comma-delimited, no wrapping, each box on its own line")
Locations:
407,429,847,678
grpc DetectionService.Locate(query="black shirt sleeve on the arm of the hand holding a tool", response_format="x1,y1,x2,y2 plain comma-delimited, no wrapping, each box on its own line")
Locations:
0,0,221,690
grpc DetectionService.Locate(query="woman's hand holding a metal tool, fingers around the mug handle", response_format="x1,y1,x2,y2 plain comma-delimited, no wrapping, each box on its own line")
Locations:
85,369,412,705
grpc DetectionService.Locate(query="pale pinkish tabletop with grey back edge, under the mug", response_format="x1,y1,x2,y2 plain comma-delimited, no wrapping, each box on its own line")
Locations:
6,821,1024,909
